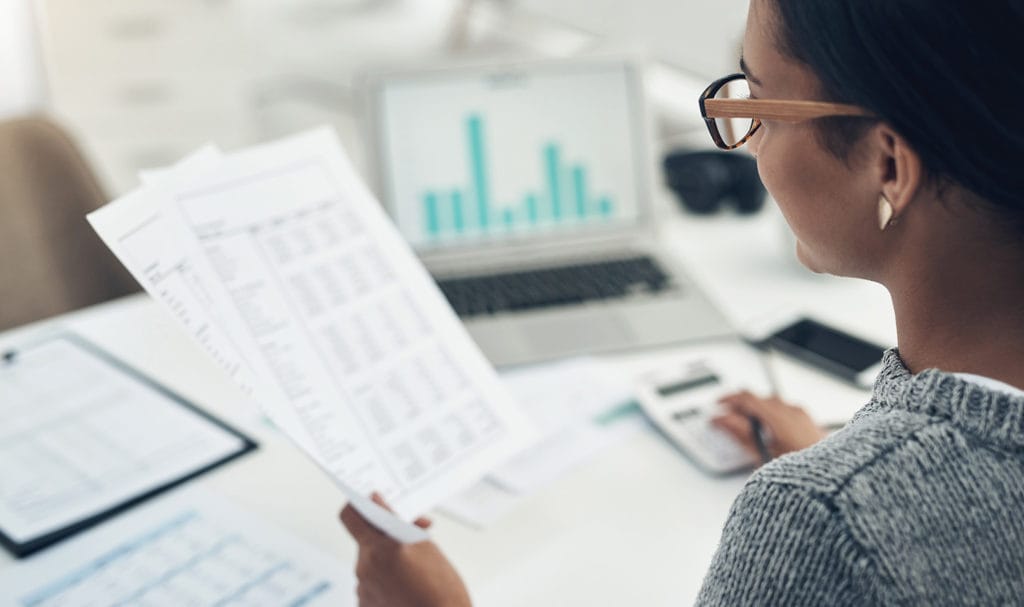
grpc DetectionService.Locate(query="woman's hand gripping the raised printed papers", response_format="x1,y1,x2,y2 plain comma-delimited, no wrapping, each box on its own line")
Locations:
341,493,471,607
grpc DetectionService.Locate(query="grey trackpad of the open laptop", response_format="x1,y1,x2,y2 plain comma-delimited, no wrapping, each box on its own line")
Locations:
522,312,633,352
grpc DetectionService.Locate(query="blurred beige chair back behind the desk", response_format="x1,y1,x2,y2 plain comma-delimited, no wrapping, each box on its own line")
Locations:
0,118,138,330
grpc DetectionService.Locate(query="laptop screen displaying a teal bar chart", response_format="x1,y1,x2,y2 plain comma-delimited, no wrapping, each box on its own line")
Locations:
378,62,646,250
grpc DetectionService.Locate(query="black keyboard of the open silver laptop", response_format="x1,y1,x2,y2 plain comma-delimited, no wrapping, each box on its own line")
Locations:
437,257,675,317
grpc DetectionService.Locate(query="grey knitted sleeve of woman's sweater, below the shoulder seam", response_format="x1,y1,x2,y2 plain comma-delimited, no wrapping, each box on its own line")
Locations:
697,480,879,606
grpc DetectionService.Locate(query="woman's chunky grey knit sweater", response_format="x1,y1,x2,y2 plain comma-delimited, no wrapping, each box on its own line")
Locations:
697,350,1024,606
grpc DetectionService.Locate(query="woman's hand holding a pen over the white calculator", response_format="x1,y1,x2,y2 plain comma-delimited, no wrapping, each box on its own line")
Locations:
713,391,827,458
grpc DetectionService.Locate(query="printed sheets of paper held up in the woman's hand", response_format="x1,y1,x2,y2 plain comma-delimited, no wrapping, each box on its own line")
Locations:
89,130,531,541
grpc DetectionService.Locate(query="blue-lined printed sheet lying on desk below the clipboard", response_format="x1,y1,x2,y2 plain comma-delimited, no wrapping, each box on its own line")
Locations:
0,489,355,607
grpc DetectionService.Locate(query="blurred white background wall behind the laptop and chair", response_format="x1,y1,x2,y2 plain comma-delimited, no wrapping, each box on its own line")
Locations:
0,0,748,193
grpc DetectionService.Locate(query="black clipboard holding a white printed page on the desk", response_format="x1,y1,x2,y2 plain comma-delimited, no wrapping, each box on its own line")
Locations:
0,334,257,558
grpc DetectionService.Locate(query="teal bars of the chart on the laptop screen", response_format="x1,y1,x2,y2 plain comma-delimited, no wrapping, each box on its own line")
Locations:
423,114,614,239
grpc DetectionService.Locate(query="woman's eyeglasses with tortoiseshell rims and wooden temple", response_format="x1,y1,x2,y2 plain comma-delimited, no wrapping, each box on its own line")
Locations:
700,74,874,149
